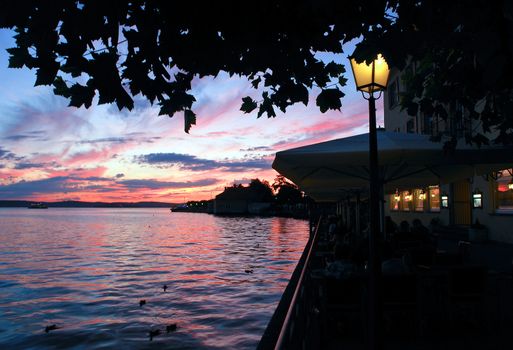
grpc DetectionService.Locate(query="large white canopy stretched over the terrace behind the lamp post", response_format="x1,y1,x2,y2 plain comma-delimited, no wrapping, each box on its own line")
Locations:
272,131,513,200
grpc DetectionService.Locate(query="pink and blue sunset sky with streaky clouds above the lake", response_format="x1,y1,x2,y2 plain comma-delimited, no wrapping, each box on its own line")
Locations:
0,30,383,202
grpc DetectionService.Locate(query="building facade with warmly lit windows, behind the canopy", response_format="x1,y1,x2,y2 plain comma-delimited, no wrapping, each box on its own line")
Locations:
384,63,513,243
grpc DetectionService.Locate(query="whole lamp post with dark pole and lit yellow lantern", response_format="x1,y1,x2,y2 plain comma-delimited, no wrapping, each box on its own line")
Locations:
350,55,389,349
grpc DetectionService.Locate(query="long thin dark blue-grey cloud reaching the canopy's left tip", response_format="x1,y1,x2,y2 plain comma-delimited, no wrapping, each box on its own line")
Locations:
136,153,271,172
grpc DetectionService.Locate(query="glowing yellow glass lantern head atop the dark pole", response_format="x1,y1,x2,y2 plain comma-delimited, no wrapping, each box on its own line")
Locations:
350,54,390,94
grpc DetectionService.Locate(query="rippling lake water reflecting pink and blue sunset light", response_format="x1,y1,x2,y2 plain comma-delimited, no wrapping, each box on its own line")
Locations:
0,208,308,349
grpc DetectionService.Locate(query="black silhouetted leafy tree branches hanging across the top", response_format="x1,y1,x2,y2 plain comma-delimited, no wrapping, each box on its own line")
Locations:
0,0,513,143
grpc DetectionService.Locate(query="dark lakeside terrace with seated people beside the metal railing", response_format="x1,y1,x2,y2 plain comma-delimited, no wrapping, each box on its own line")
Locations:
259,221,513,350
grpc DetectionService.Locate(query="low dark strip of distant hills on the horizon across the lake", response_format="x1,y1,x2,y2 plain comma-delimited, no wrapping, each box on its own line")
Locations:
0,200,177,208
